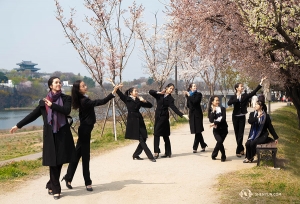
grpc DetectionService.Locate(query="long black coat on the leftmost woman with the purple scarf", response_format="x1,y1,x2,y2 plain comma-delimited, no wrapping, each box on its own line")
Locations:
17,94,75,166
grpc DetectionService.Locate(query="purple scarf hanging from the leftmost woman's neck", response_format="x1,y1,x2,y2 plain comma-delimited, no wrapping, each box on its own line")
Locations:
45,91,66,133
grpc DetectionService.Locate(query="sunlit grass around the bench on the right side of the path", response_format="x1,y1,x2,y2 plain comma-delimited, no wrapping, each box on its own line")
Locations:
217,106,300,203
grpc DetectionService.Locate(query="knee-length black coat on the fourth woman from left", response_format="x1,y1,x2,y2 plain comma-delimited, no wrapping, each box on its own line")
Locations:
149,90,183,136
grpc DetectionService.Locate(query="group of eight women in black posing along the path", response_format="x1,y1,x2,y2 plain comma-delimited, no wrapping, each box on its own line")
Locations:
10,77,278,200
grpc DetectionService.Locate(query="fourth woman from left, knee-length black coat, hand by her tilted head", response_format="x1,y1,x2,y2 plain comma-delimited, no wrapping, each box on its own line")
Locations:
149,83,188,158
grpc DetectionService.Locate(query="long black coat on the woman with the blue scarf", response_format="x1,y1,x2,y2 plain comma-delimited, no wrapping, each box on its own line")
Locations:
187,92,204,134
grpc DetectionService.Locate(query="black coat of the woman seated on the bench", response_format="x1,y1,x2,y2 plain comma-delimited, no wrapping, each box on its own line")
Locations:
248,112,279,140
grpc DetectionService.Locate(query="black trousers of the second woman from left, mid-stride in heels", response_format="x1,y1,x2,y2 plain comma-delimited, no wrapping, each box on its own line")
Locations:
65,125,94,186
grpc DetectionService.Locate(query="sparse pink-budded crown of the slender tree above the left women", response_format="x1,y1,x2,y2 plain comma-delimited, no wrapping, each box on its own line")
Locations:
55,0,143,86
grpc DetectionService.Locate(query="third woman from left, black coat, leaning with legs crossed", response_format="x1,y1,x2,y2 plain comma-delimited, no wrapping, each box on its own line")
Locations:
117,85,156,162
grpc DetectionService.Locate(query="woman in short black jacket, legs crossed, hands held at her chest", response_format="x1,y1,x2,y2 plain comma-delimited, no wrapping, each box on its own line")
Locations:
208,96,228,162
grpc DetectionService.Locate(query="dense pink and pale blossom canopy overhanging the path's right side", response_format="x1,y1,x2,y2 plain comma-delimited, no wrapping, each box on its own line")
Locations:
167,0,300,126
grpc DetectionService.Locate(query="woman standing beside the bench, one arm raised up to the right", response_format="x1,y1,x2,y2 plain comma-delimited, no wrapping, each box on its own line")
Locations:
227,77,267,157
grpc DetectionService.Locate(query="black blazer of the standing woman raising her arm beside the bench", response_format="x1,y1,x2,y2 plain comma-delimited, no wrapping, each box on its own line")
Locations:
227,85,262,115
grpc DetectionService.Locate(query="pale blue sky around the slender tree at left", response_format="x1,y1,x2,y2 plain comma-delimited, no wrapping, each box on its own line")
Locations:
0,0,165,81
